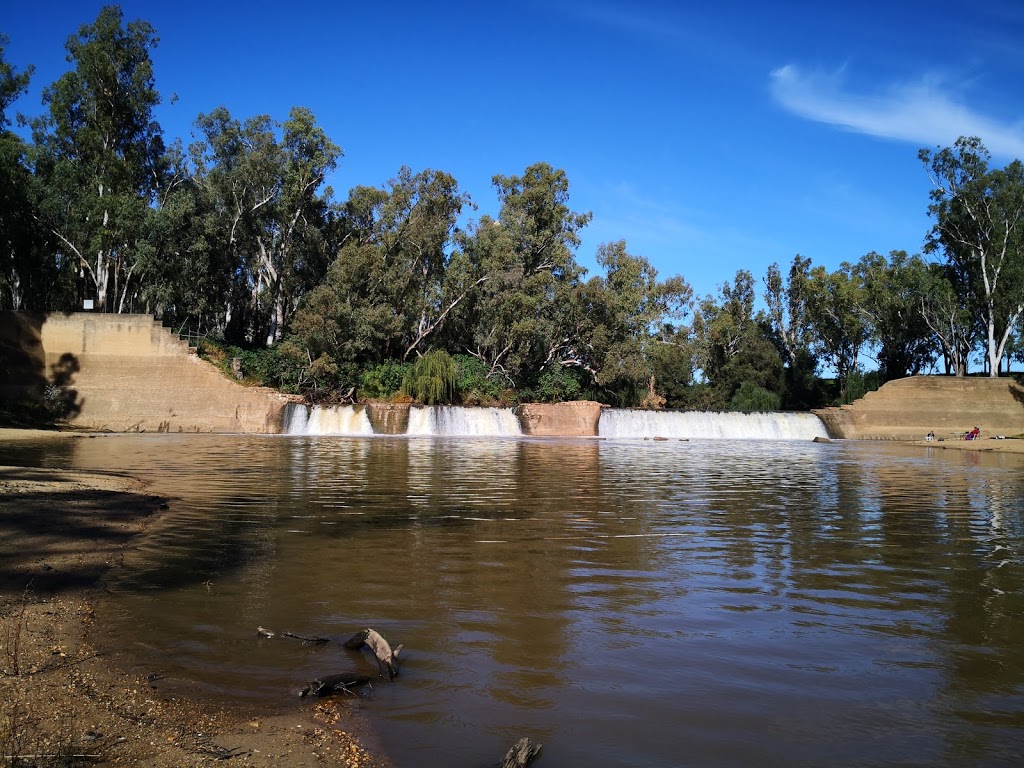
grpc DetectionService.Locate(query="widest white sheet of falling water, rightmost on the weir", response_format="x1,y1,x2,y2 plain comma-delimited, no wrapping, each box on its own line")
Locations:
598,409,828,440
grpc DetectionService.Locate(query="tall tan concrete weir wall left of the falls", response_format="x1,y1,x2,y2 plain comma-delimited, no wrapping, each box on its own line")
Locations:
6,312,288,433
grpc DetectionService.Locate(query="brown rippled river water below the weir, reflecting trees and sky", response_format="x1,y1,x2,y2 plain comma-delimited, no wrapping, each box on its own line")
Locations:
6,435,1024,768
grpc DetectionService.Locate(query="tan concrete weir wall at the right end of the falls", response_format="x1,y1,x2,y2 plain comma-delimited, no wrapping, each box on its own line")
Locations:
814,376,1024,440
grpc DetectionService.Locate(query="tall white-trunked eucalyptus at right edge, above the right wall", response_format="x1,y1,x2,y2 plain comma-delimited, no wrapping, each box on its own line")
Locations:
919,136,1024,377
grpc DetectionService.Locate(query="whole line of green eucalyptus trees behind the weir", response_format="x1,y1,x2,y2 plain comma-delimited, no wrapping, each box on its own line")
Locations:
0,6,1024,410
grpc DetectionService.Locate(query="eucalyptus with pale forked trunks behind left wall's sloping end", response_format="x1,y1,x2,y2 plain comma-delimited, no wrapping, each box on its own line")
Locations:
190,106,341,346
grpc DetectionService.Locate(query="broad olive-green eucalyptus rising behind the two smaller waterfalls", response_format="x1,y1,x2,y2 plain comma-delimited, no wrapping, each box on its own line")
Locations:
293,168,473,370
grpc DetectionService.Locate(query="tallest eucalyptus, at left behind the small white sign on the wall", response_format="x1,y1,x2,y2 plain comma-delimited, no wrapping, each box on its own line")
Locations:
33,5,165,311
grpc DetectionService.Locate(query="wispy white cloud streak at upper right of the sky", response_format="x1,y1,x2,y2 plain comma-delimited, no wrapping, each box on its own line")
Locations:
771,65,1024,158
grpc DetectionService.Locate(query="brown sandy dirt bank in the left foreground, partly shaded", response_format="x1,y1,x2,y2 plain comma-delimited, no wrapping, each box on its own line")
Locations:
0,456,387,768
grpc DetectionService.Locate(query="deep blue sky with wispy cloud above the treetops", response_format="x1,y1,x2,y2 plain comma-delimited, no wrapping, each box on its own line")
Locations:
0,0,1024,303
